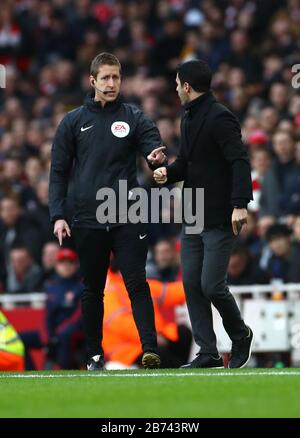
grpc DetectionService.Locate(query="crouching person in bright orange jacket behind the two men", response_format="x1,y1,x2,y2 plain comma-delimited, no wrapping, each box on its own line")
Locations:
103,261,192,368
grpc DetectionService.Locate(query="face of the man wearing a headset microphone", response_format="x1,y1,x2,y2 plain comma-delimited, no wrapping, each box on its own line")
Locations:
90,65,121,103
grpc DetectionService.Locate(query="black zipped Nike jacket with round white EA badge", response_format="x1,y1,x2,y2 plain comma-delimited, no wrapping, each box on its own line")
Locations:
49,95,161,228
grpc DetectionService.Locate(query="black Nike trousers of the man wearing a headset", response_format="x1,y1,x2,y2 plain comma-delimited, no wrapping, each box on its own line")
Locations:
72,223,157,358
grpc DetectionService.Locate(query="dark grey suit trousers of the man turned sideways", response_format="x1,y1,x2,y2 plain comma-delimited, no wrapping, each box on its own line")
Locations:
181,225,248,355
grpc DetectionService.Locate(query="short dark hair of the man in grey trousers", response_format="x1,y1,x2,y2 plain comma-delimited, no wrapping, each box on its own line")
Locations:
177,59,212,92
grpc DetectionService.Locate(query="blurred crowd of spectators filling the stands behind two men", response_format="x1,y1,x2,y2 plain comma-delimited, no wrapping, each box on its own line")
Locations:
0,0,300,370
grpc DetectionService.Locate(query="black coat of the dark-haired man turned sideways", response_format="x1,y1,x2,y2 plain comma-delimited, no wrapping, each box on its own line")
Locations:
167,91,252,227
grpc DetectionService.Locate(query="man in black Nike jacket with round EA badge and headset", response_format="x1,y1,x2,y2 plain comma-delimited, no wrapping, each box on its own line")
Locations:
49,53,166,370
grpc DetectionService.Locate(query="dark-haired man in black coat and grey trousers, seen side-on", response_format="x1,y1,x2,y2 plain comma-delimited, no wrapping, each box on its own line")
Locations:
154,60,253,368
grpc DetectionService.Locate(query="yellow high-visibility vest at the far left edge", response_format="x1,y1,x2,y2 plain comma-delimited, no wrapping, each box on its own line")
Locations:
0,312,24,357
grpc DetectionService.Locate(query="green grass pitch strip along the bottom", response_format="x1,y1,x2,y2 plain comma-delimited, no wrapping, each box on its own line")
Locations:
0,368,300,418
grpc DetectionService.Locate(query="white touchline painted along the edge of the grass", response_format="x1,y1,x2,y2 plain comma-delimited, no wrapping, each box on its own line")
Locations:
0,371,300,379
